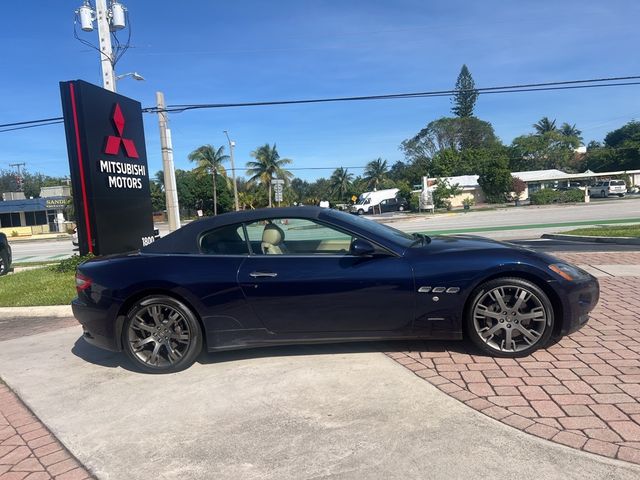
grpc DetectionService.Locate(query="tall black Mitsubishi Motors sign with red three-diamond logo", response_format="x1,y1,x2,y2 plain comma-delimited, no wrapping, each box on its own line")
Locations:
60,80,153,255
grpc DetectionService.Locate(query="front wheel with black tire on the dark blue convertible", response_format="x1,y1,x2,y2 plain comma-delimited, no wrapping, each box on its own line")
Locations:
465,278,554,357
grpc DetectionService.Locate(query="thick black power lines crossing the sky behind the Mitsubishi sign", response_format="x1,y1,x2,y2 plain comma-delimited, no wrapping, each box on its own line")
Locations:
5,75,640,133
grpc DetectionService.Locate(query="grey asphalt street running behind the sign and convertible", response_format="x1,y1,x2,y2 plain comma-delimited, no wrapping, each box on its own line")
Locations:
10,198,640,262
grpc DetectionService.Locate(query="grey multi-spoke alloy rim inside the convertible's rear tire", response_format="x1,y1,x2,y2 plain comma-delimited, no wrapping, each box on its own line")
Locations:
127,303,193,367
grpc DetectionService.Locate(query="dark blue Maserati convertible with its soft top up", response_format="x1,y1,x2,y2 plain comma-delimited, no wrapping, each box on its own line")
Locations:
73,207,599,373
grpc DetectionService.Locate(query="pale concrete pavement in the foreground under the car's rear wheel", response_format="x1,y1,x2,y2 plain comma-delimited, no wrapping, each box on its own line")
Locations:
0,328,640,480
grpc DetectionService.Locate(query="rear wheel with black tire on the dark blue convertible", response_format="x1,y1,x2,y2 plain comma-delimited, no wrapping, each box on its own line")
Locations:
122,295,202,373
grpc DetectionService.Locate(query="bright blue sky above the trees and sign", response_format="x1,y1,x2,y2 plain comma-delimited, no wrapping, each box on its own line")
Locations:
0,0,640,179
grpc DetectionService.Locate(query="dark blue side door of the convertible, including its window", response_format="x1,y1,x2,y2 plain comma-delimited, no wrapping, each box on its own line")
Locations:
238,218,415,336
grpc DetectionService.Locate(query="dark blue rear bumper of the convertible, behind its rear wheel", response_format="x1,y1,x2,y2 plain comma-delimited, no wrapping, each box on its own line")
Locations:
71,297,122,352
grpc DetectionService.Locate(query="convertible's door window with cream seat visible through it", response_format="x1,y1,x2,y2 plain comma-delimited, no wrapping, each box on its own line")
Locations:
247,218,353,255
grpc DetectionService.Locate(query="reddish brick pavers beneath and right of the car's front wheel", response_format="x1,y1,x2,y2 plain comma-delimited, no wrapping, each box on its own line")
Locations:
388,253,640,464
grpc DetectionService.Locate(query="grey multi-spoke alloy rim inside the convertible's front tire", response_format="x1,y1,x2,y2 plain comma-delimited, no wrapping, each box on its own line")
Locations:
473,285,549,353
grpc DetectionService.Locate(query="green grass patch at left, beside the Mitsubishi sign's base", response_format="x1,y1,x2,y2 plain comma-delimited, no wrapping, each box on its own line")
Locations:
0,267,76,307
